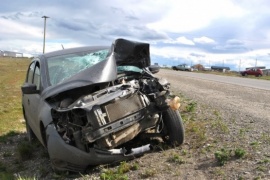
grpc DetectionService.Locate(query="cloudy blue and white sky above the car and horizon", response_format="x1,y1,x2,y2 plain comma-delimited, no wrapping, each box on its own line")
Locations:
0,0,270,71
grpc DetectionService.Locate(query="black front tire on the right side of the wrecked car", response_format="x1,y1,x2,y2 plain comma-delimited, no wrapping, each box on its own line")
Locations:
162,108,185,146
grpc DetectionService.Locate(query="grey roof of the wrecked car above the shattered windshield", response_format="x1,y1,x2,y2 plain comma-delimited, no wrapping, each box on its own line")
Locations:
40,46,110,58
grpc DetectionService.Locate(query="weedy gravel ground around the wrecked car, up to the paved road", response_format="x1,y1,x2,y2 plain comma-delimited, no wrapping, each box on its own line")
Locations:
0,70,270,180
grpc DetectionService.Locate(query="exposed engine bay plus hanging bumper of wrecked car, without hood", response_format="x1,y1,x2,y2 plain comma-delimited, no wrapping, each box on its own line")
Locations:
46,73,169,171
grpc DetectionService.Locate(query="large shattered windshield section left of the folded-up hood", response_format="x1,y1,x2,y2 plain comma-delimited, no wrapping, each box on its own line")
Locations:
47,49,109,85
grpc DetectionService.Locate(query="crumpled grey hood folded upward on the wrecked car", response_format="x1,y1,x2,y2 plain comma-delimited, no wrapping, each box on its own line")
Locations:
42,39,150,99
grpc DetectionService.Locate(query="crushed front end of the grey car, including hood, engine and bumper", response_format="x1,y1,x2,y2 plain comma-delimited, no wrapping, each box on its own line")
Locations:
38,39,182,172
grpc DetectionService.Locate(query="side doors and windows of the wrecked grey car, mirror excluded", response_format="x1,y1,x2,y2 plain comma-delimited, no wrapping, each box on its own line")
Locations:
23,61,41,136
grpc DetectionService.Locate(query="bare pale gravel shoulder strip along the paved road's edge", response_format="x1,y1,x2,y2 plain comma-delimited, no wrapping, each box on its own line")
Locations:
159,70,270,126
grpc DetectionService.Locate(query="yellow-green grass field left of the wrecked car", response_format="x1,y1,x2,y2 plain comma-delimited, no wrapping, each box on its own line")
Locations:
0,57,30,137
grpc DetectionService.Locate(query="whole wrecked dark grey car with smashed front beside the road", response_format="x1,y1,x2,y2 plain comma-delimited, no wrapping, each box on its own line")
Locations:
22,39,184,172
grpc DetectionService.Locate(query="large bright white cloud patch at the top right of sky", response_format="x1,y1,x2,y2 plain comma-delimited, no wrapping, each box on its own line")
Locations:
148,0,246,33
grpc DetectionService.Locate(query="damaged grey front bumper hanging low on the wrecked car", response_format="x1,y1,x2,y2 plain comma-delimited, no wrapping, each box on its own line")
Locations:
46,124,151,172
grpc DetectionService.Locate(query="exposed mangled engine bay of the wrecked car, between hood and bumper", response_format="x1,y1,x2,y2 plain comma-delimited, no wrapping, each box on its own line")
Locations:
50,71,170,152
